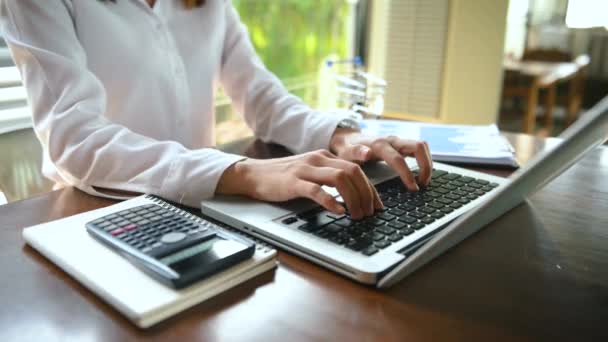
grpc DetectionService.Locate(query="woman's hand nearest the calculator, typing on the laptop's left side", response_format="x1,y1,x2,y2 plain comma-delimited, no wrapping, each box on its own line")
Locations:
216,150,383,219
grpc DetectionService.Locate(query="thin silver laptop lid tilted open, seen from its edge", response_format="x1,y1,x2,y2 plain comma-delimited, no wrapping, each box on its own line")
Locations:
378,96,608,287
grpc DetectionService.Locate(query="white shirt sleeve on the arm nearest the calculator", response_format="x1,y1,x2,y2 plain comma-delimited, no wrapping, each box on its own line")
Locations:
0,0,243,206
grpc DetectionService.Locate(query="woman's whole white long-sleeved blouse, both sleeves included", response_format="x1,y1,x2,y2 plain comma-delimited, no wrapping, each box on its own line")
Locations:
0,0,342,206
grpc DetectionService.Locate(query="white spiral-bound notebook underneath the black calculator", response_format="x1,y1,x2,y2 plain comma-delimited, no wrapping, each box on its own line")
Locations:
23,196,277,328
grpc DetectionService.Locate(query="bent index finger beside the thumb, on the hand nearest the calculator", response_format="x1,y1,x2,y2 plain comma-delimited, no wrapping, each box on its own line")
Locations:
297,166,364,219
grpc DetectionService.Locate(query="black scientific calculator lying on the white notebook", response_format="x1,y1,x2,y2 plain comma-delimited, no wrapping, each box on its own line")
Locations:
86,204,255,288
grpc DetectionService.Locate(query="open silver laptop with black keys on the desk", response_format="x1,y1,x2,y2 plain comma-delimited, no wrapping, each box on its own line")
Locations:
201,97,608,288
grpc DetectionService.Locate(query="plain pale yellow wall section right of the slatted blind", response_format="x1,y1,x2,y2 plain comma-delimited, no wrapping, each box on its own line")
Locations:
440,0,508,124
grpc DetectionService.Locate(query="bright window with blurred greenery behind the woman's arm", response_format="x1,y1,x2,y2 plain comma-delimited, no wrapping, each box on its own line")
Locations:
216,0,357,144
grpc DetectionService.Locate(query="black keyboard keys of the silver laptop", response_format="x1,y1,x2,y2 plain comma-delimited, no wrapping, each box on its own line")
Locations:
294,170,498,256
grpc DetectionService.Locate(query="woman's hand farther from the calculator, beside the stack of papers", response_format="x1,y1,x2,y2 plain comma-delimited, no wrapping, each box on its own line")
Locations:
330,128,433,191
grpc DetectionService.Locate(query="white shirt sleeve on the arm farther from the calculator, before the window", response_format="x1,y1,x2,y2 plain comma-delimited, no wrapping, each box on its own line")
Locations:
220,0,348,153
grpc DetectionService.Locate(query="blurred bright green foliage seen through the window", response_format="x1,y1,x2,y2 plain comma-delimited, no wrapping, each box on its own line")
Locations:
233,0,349,79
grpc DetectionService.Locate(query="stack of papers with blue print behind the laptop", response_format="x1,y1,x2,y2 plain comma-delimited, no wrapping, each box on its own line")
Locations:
361,119,519,167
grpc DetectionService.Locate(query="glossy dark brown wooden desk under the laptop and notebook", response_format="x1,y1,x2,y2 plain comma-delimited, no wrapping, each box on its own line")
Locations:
0,135,608,342
